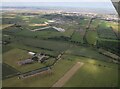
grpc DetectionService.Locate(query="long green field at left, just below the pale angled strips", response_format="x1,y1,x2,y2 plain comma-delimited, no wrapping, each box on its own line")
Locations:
3,26,65,39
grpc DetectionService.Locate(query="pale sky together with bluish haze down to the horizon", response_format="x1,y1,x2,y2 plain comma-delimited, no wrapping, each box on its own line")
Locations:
2,0,116,13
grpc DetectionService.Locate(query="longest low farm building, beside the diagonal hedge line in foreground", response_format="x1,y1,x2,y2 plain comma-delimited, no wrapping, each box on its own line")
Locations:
19,67,51,79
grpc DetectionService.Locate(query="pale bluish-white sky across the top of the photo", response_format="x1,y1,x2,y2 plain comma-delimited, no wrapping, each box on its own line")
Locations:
0,0,116,12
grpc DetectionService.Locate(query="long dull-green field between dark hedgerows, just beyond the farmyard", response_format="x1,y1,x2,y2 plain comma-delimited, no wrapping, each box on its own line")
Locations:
15,38,69,52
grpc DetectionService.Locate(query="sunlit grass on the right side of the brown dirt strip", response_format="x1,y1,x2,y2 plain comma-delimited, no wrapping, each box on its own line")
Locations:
64,55,118,87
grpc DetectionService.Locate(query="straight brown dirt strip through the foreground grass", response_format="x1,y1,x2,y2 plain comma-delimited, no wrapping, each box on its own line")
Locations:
51,62,84,89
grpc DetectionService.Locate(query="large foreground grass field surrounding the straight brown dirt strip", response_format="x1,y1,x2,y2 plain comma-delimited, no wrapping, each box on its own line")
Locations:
3,48,118,87
